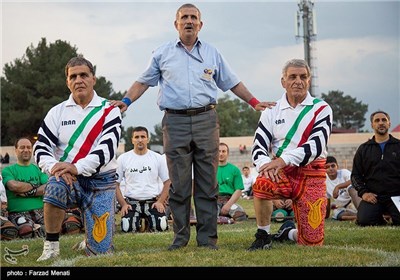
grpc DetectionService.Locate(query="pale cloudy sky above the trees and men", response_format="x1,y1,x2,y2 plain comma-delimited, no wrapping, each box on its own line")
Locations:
1,0,400,131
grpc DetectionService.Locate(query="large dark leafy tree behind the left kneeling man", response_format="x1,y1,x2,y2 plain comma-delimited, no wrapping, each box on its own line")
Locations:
1,38,123,146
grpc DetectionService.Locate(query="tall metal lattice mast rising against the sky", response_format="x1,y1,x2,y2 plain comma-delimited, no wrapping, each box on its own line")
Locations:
295,0,318,96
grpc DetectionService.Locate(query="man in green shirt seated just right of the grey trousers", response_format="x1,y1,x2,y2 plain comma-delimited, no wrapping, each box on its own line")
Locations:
217,143,247,223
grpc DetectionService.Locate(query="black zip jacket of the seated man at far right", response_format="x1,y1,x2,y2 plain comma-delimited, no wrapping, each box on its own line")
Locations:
351,135,400,198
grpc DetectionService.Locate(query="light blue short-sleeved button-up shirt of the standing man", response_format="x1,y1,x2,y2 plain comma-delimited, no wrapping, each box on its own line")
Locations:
137,39,240,110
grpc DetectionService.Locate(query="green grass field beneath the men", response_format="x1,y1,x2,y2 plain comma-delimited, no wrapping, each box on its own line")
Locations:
1,199,400,268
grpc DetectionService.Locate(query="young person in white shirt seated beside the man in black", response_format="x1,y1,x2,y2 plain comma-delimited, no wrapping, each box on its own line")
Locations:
325,156,361,221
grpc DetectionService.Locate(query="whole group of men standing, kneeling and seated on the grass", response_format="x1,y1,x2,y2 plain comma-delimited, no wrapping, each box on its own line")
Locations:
0,4,400,261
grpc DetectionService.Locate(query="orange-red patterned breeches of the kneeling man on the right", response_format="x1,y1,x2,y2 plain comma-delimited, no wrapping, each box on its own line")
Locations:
253,159,327,246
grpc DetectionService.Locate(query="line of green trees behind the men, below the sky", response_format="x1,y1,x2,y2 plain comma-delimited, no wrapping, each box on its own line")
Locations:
1,38,368,150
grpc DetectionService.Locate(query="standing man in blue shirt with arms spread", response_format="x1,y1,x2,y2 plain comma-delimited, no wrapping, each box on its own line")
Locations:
112,4,274,250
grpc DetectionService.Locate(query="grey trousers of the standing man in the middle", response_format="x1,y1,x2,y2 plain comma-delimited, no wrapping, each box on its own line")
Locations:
162,109,219,246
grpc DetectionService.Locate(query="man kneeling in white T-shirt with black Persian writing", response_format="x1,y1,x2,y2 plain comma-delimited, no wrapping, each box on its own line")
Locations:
117,126,171,232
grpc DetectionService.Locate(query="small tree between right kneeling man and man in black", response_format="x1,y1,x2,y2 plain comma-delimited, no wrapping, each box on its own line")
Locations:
321,90,368,132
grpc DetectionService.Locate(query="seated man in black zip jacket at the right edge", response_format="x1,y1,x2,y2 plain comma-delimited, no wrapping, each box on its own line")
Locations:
351,111,400,226
